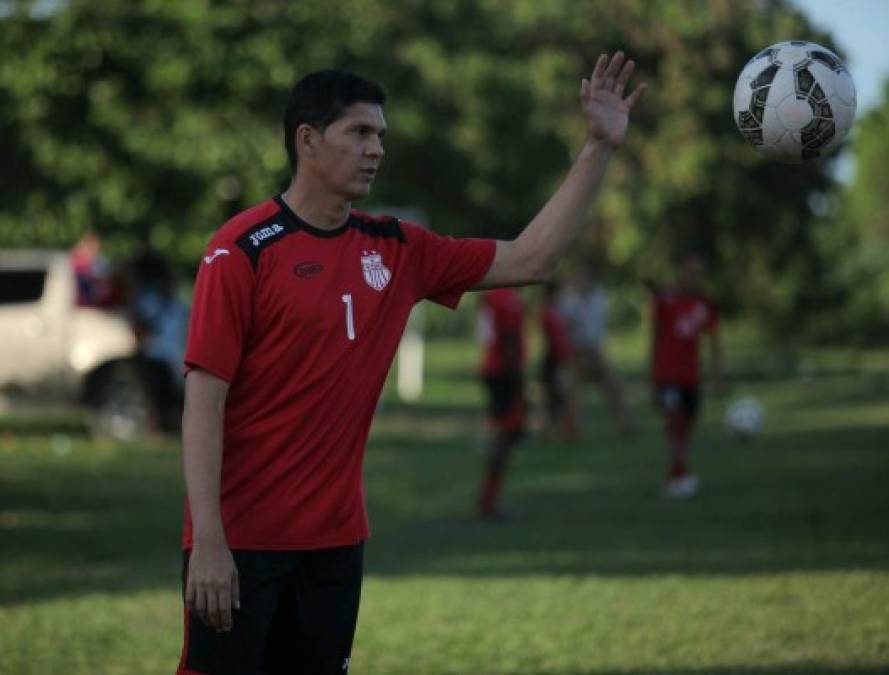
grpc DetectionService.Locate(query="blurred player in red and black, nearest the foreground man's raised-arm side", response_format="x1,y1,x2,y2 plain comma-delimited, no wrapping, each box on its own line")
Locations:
478,288,527,520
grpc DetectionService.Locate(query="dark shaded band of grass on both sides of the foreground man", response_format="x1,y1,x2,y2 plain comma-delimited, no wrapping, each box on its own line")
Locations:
0,386,889,608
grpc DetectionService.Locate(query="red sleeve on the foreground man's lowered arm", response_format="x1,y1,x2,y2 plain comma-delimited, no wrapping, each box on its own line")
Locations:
185,240,255,382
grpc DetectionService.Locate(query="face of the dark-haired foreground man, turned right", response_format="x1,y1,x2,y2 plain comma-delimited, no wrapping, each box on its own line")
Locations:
313,103,386,200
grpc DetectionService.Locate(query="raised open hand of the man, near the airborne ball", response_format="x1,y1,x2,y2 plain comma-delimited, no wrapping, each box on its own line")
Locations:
580,52,647,147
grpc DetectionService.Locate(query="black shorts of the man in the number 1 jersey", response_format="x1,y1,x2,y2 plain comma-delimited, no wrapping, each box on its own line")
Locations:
179,543,364,675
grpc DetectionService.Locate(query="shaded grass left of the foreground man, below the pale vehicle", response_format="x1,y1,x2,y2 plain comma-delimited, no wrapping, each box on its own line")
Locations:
0,449,182,605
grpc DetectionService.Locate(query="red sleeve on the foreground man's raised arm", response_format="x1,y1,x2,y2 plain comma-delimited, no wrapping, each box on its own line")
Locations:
407,225,497,309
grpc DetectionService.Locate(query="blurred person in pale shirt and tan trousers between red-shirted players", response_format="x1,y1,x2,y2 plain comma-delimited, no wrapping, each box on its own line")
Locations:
558,267,631,435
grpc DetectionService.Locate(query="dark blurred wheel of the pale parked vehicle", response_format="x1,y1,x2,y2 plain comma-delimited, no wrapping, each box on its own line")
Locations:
89,363,154,441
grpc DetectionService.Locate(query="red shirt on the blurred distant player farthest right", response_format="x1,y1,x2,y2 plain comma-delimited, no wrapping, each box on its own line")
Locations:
652,289,719,386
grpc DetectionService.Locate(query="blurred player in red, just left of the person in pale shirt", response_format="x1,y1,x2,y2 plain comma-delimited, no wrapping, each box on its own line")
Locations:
540,280,578,441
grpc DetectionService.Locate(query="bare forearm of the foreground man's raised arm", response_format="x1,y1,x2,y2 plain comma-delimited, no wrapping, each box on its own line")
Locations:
515,141,614,281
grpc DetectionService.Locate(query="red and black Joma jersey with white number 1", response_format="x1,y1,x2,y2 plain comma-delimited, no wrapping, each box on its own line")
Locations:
183,197,495,550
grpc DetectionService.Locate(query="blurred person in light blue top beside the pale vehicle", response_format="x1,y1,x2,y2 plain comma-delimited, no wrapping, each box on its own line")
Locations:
130,249,189,431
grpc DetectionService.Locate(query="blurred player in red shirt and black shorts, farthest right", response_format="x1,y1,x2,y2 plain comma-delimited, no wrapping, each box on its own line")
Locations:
649,255,722,497
